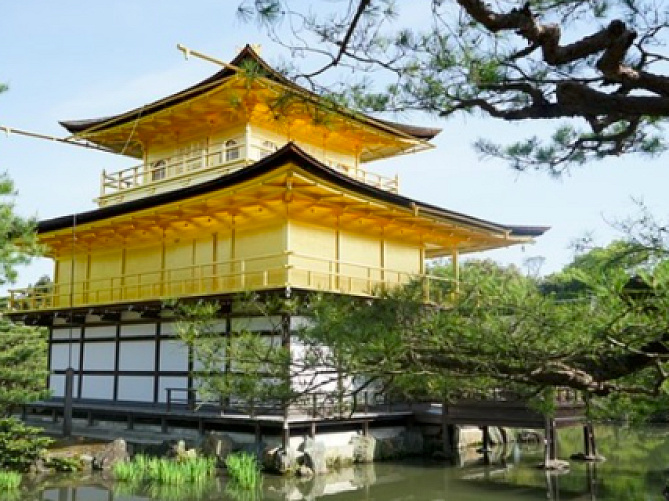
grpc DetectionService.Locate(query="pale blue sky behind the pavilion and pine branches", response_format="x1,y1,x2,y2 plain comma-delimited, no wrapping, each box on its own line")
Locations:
0,0,669,286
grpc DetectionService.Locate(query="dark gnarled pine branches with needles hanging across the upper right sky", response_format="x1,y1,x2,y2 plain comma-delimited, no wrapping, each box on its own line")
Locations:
239,0,669,176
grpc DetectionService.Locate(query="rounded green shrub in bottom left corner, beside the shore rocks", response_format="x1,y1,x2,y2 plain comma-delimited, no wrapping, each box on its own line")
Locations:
0,418,53,471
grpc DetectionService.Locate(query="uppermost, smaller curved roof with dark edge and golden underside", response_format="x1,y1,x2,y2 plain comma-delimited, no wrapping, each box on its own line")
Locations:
60,45,441,161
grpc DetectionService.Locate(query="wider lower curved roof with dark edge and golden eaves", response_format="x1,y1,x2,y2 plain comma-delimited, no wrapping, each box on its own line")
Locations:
38,143,549,257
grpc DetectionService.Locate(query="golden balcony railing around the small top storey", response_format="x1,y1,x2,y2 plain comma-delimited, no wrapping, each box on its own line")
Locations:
100,141,399,197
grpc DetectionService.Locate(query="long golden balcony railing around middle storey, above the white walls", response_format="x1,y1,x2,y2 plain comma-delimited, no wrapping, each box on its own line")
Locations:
9,252,455,312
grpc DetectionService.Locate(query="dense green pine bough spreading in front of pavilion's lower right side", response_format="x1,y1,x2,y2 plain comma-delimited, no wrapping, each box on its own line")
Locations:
305,236,669,416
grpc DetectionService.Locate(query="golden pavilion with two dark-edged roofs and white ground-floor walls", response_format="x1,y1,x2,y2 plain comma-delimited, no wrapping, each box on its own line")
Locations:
11,47,545,442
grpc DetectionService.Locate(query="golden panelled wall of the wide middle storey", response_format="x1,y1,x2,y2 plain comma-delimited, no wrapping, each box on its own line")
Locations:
48,204,422,306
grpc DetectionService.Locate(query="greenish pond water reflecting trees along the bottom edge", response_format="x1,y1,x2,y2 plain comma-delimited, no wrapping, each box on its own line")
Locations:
11,427,669,501
